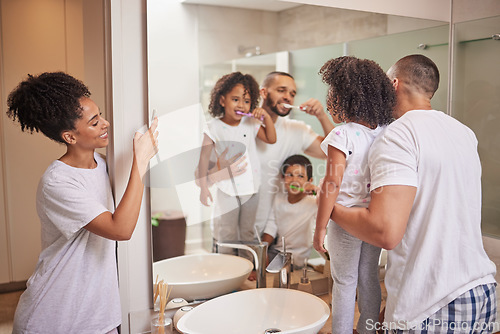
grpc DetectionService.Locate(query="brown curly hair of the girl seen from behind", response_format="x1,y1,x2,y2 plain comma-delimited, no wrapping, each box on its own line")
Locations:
319,56,396,127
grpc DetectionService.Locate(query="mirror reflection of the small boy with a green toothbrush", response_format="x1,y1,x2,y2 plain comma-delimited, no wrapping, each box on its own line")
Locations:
262,155,318,268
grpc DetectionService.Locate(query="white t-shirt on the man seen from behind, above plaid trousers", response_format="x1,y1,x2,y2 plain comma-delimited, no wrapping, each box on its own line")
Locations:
368,110,496,328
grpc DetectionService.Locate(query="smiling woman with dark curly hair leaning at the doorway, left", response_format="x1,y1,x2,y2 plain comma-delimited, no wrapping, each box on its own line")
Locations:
7,72,158,334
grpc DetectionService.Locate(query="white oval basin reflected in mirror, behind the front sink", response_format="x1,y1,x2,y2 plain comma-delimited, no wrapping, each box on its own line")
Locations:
153,254,253,301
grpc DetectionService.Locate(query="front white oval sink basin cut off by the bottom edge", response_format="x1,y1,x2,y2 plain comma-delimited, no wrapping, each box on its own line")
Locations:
177,288,330,334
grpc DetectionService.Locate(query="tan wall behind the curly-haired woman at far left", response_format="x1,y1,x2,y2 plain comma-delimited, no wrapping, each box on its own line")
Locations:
0,0,105,284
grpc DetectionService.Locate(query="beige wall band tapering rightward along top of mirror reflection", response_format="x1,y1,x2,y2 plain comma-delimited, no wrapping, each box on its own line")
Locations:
195,4,441,66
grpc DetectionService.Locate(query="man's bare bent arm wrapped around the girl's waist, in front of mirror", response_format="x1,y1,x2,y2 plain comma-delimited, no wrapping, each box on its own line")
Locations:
331,185,417,249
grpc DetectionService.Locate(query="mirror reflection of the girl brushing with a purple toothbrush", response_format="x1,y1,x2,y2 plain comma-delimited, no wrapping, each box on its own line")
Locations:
198,72,276,251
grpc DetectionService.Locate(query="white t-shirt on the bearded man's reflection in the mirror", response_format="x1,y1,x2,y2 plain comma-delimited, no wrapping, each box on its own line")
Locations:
255,117,318,231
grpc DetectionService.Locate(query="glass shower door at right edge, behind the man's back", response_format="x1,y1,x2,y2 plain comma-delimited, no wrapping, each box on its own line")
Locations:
452,16,500,238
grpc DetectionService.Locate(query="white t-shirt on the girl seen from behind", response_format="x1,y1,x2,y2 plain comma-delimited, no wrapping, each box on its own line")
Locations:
321,122,383,208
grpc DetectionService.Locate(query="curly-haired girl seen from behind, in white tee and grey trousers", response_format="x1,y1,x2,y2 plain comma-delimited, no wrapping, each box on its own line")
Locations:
314,57,396,334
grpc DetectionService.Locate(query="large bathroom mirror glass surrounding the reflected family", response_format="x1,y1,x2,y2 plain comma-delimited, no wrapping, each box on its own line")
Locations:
147,0,449,268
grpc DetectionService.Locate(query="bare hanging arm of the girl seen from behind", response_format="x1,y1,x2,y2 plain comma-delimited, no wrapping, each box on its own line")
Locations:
314,146,346,252
